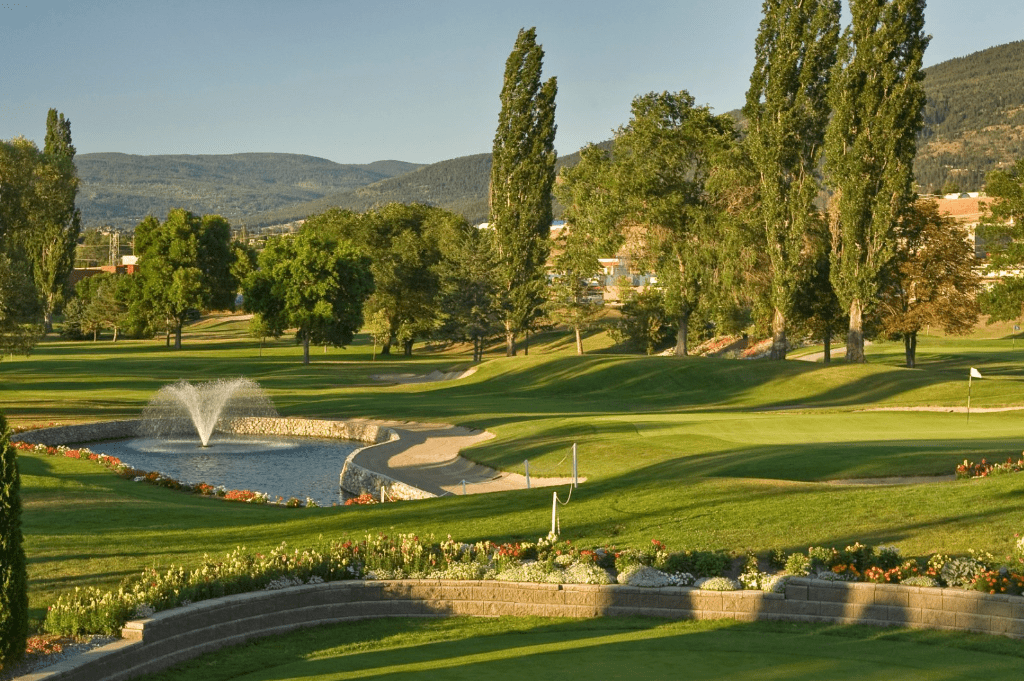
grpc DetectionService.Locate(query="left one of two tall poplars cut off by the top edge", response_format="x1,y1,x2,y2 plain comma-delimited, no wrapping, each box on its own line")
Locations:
743,0,840,359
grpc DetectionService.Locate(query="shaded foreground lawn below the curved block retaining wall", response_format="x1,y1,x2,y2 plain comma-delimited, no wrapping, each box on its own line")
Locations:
136,618,1024,681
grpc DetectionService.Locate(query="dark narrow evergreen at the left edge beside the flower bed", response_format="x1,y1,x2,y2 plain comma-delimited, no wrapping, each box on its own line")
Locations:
0,414,29,669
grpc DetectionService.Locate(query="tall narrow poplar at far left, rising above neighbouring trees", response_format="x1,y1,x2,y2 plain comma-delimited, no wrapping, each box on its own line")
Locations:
36,109,82,333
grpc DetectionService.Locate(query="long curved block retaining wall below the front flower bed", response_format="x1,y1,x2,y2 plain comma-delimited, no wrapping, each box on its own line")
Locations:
18,578,1024,681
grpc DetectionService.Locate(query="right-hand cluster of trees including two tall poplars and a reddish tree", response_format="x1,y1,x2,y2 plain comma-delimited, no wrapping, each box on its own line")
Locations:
555,0,977,366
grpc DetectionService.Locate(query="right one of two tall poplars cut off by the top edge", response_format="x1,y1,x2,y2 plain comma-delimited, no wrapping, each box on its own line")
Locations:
825,0,931,363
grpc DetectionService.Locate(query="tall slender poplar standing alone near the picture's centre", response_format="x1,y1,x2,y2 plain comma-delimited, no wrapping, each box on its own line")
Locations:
490,29,558,356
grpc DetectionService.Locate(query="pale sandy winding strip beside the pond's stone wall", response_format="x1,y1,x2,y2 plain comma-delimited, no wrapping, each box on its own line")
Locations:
355,420,586,496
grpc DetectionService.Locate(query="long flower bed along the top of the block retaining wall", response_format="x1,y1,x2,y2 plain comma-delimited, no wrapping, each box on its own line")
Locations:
44,535,1024,636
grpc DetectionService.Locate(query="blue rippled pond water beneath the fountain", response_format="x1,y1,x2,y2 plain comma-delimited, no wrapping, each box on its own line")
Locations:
90,434,365,506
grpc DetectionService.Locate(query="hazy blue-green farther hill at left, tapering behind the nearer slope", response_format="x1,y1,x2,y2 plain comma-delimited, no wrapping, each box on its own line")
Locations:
75,154,420,228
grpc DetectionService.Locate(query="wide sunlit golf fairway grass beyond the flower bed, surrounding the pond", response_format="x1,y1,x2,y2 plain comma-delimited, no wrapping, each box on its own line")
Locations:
6,317,1024,623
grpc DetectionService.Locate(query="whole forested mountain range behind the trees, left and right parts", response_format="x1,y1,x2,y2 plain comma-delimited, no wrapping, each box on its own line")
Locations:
76,41,1024,230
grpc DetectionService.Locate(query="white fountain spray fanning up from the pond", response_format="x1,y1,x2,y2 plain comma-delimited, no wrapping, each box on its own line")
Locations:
139,378,278,448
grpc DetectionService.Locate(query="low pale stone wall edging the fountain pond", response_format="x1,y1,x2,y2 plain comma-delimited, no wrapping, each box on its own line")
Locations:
17,418,436,500
